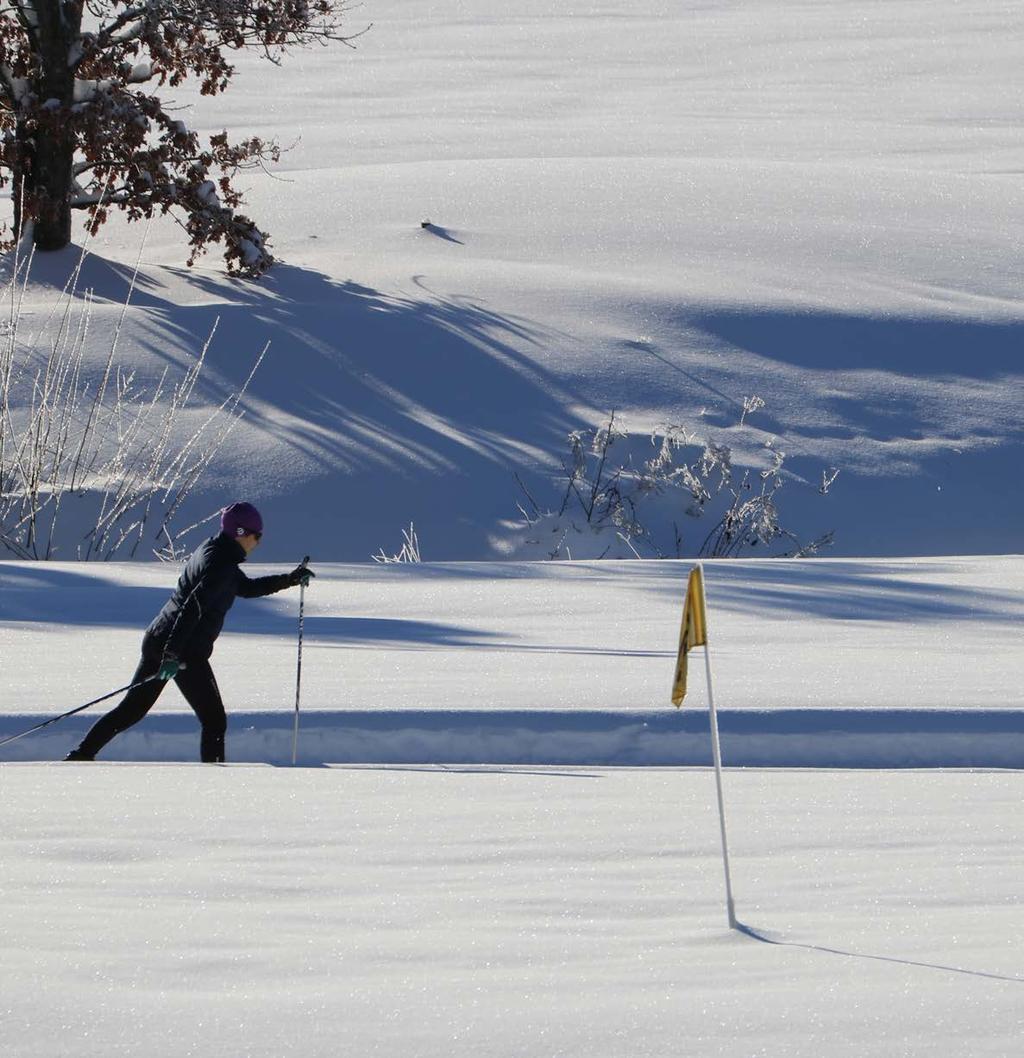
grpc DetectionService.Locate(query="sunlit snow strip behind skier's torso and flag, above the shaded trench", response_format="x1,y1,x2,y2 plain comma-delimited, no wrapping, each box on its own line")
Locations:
0,557,1024,713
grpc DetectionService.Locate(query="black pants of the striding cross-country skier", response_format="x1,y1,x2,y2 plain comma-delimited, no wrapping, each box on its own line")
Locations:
78,640,227,764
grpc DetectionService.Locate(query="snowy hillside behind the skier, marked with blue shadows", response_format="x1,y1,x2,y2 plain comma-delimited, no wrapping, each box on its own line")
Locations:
3,0,1024,562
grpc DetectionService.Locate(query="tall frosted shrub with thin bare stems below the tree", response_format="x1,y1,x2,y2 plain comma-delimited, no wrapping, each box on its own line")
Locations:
0,248,267,559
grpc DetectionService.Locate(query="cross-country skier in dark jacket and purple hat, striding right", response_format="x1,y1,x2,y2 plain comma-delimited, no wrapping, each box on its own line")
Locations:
65,504,314,764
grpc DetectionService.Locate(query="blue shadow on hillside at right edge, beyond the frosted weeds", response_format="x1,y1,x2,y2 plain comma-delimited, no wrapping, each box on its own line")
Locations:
623,306,1024,555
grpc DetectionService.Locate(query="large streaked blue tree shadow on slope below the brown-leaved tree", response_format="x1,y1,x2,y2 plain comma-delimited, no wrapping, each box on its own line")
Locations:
17,251,582,561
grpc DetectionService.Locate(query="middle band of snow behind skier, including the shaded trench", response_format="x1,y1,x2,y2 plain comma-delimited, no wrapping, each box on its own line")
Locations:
0,557,1024,766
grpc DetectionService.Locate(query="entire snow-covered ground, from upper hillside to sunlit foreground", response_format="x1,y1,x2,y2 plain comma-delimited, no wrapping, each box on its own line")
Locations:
0,6,1024,1058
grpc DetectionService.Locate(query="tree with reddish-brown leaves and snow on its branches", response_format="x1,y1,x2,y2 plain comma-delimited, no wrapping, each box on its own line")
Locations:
0,0,352,275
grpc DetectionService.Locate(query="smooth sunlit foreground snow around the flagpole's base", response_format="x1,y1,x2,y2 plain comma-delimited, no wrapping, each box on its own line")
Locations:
0,765,1024,1058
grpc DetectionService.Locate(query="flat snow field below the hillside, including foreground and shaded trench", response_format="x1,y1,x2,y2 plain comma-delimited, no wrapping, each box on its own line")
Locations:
6,558,1024,1058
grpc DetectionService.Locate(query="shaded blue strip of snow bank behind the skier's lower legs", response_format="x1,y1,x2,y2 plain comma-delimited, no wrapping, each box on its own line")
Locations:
0,708,1024,768
